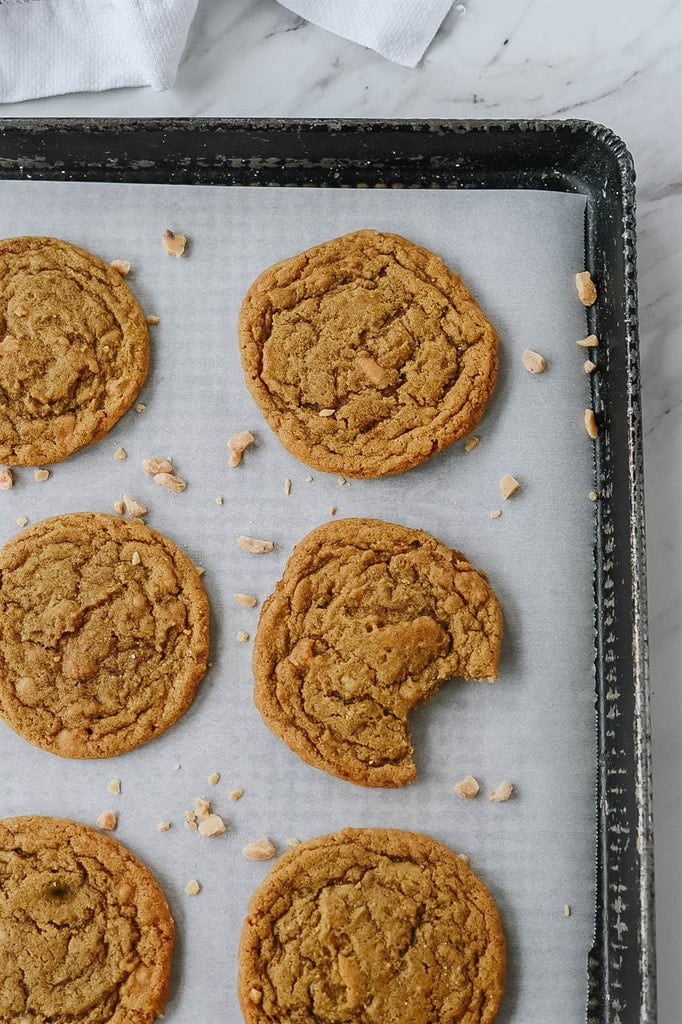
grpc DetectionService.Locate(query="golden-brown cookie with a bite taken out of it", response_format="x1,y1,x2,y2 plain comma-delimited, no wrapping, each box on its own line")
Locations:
253,519,502,786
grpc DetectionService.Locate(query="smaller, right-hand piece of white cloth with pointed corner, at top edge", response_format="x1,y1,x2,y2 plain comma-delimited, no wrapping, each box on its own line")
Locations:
280,0,453,68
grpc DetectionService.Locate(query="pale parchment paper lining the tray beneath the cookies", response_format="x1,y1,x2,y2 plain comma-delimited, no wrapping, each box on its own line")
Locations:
0,181,596,1024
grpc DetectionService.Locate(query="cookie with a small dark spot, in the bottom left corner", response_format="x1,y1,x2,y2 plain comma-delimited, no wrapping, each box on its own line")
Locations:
0,817,174,1024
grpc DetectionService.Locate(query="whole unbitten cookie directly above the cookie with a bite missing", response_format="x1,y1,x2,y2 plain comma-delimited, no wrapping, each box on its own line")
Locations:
239,230,498,477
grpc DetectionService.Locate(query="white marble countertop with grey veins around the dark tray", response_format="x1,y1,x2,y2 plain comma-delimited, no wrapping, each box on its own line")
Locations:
0,0,682,1024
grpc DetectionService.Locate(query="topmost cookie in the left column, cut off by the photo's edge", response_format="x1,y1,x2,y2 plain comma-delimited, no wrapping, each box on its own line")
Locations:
0,238,150,466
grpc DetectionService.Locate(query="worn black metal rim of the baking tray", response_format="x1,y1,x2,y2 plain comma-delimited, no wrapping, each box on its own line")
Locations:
0,120,655,1024
